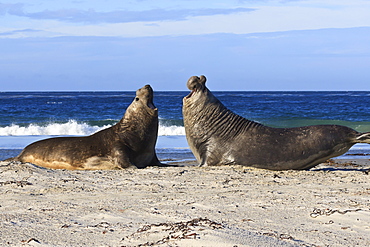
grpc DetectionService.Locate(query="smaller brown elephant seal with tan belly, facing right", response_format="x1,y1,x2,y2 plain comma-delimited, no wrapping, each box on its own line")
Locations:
13,85,162,170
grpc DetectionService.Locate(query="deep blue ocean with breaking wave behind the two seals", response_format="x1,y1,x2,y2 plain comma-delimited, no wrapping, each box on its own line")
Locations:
0,91,370,161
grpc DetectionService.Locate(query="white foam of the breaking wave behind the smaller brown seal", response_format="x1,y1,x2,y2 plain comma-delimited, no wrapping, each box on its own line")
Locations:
0,120,185,136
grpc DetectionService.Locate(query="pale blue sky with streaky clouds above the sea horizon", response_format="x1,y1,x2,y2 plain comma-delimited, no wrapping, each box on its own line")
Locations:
0,0,370,91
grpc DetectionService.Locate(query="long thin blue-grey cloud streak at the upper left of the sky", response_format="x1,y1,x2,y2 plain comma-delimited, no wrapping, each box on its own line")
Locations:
0,4,255,23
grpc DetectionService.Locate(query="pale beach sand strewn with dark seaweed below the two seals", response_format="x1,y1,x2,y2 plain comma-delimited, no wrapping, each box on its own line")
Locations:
0,159,370,247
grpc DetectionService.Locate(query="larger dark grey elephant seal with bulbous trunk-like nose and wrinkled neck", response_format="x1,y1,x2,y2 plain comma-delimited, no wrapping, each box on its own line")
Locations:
182,76,370,170
